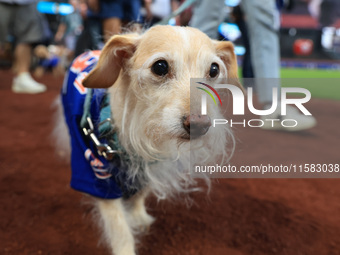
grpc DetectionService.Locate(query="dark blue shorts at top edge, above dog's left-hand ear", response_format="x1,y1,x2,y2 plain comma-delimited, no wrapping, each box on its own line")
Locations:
99,0,141,22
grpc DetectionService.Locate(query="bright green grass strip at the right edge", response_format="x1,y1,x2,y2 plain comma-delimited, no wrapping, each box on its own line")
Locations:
281,68,340,100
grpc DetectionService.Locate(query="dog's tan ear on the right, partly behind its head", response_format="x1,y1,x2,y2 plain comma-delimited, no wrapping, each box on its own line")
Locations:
215,41,243,88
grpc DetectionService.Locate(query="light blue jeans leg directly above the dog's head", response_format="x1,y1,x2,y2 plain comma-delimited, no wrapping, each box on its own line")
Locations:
190,0,225,39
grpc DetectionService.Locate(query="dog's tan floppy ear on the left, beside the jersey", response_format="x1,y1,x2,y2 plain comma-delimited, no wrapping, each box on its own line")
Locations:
83,34,139,88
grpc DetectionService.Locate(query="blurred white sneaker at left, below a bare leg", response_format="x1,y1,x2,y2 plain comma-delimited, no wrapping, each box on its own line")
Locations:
12,72,46,94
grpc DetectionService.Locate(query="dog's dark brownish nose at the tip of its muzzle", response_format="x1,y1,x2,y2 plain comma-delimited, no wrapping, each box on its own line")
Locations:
183,114,211,138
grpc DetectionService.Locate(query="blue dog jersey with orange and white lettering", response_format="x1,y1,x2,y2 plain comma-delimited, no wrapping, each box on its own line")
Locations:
62,51,125,199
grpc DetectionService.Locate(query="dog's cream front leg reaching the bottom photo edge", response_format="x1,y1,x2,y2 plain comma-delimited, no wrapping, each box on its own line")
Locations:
98,199,135,255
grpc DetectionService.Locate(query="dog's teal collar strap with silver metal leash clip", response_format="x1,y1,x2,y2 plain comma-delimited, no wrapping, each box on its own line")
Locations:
80,89,128,161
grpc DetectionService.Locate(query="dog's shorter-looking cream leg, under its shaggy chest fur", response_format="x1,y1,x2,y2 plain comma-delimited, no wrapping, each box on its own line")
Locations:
125,189,155,232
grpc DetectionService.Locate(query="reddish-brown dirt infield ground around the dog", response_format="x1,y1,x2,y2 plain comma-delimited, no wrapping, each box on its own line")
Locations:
0,70,340,255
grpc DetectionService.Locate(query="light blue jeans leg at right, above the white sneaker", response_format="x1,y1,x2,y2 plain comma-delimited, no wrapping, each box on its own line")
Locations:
242,0,280,104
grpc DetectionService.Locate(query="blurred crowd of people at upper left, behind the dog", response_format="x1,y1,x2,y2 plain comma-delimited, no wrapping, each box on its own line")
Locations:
0,0,186,94
